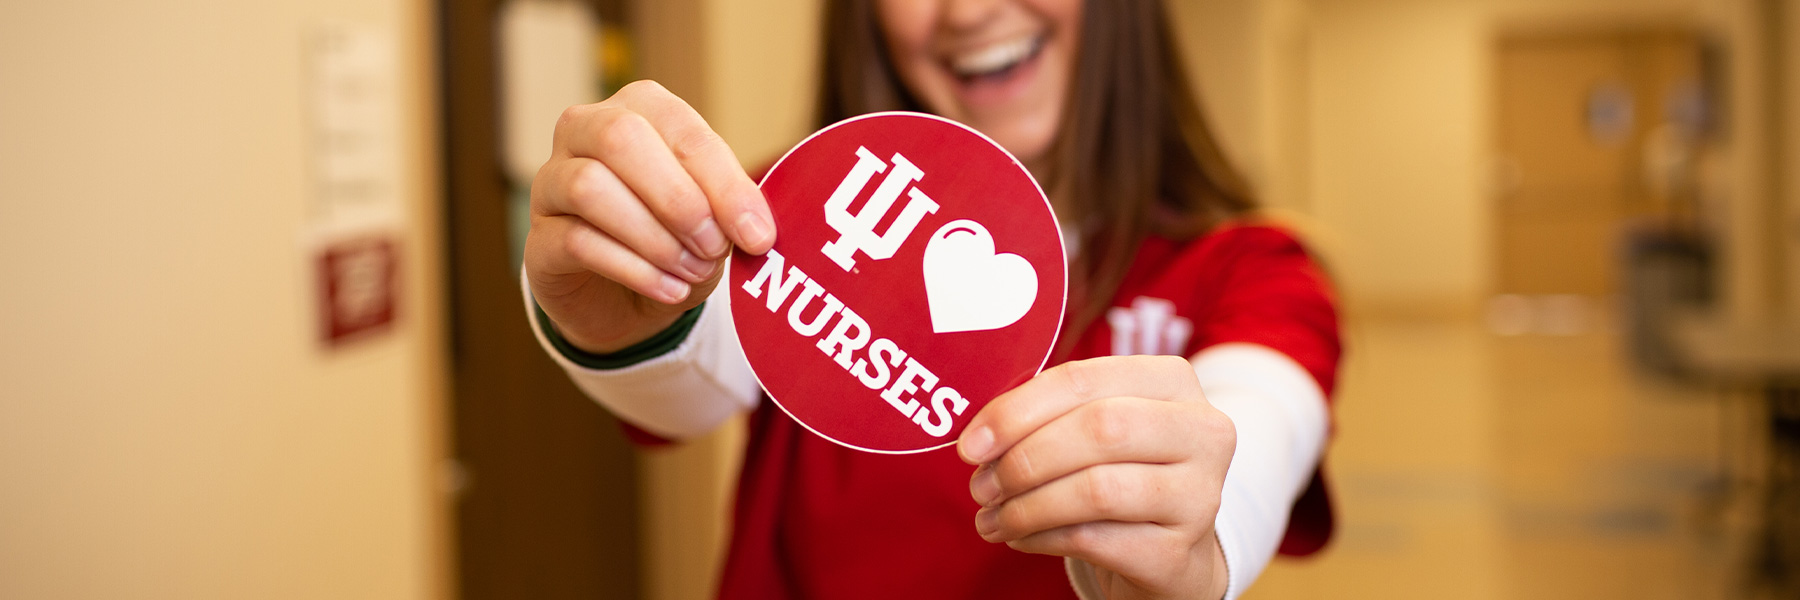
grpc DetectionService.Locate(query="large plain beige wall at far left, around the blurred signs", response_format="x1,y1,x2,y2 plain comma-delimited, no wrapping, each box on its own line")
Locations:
0,0,445,598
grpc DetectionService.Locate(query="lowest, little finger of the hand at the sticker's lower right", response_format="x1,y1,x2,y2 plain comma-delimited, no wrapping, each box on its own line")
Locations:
1006,521,1188,582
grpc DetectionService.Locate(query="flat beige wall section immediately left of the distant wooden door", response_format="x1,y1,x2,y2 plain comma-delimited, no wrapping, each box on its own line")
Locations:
1307,2,1489,310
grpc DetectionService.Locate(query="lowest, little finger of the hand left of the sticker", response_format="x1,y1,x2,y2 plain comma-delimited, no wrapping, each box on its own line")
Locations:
526,214,693,305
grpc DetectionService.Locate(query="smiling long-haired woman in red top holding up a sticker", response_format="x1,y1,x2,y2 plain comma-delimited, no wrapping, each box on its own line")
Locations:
524,0,1339,598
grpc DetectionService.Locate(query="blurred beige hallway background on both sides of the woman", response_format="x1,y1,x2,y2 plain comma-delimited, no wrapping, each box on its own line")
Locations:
0,0,1800,600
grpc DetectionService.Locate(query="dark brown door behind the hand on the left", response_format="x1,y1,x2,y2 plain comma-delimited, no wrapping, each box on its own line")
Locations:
439,0,641,600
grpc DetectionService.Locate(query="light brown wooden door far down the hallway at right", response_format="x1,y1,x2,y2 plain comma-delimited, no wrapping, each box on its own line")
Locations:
1496,31,1706,295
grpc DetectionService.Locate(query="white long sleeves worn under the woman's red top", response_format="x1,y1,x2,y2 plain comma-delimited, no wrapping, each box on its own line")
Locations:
520,272,1328,600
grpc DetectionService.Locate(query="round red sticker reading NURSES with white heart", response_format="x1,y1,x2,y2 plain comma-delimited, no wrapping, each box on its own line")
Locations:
729,112,1067,454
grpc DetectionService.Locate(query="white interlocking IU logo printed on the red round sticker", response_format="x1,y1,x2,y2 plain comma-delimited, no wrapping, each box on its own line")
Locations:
821,146,938,270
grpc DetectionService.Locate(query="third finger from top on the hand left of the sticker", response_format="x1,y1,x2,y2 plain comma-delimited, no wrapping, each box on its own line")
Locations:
533,159,718,283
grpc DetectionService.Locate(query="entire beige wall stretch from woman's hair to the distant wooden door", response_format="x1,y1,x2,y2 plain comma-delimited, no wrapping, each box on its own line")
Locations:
1172,0,1489,312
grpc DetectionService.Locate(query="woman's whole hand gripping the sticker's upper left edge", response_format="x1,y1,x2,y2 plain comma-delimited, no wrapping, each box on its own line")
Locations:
526,81,776,353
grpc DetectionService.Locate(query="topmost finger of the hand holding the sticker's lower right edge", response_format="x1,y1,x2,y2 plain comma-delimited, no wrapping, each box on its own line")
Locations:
958,357,1199,465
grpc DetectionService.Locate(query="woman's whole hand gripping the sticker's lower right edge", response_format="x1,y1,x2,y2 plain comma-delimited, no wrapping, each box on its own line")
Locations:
958,357,1237,600
